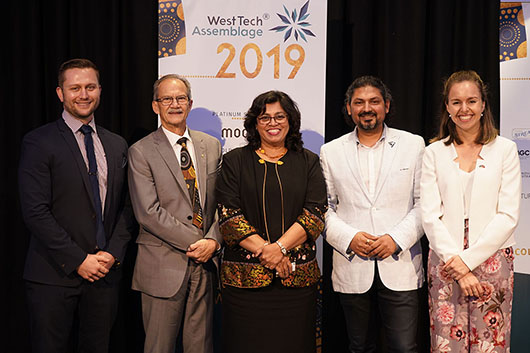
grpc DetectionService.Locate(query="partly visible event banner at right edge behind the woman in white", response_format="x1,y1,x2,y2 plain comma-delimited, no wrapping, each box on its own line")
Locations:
499,2,530,274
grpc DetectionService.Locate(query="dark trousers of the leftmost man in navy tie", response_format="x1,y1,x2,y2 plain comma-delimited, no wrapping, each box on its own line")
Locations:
26,279,119,353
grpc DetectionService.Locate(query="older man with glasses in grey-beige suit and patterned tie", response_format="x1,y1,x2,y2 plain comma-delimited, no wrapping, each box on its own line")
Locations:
129,74,221,353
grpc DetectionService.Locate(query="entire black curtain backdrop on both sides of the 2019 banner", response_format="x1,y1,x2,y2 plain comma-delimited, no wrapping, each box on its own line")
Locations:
4,0,499,353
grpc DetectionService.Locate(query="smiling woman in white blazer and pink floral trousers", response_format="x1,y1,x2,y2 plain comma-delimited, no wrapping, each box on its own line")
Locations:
420,71,521,353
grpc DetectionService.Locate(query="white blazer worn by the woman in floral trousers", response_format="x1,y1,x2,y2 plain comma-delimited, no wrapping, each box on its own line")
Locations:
421,136,521,270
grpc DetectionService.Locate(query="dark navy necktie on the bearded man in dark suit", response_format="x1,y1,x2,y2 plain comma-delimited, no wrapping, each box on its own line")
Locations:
79,124,107,250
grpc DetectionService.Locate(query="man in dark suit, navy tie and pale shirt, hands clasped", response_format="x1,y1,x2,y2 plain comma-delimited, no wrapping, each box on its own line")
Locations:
19,59,131,353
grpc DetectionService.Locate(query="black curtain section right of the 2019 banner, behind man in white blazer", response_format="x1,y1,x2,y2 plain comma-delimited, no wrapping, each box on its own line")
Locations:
323,0,500,353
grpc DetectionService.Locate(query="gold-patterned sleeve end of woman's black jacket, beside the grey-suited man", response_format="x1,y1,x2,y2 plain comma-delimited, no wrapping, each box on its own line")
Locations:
218,204,258,246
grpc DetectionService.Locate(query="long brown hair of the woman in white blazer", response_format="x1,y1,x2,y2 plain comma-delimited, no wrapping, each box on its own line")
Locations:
430,70,499,145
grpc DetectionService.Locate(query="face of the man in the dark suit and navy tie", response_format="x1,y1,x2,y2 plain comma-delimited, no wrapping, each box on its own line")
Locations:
56,68,101,123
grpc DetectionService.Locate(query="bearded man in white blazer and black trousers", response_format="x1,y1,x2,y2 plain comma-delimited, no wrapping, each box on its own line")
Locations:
320,76,425,352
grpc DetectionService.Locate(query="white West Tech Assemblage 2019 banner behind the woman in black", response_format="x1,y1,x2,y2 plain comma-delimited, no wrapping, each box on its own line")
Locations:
158,0,327,153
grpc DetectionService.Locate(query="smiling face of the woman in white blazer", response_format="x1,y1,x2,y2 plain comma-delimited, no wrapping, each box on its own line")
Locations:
445,81,485,136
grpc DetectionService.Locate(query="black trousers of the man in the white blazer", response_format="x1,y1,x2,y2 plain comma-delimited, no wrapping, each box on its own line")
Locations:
339,264,419,353
